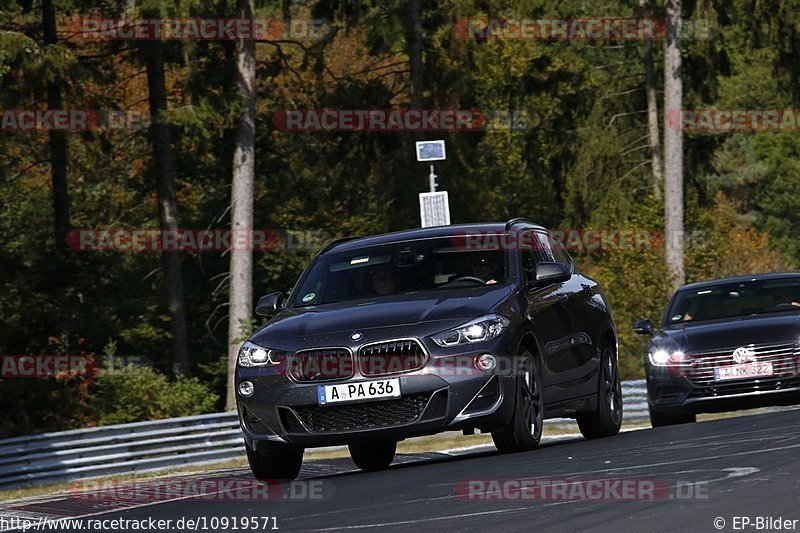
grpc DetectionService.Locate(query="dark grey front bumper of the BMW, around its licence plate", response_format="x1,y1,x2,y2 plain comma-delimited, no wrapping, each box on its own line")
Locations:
236,336,516,449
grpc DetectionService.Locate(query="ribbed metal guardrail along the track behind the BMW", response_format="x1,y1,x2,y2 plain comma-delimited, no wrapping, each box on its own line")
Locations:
0,380,647,490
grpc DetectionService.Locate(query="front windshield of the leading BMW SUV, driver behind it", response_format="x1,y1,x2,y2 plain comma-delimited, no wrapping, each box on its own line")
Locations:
294,238,508,307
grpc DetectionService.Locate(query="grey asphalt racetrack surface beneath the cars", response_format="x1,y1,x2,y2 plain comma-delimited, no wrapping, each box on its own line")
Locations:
4,410,800,533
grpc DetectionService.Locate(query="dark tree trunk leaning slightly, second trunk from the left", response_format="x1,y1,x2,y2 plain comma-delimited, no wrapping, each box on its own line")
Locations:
142,40,189,376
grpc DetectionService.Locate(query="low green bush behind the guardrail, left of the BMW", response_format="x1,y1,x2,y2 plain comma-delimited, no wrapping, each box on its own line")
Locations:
89,366,219,426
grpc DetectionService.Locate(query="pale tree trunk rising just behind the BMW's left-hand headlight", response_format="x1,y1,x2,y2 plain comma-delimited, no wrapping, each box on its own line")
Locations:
225,0,256,409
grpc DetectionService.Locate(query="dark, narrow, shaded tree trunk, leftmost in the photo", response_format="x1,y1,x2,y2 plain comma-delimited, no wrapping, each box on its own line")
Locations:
42,0,70,250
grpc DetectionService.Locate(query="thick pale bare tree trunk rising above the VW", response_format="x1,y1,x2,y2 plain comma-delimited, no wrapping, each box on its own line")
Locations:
664,0,685,291
